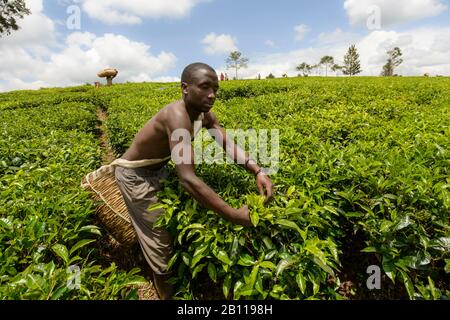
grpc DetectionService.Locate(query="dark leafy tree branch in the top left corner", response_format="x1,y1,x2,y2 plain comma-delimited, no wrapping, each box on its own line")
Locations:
0,0,31,36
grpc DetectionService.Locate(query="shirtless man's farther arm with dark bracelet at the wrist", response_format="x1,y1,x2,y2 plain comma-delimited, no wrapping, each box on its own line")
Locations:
206,112,273,200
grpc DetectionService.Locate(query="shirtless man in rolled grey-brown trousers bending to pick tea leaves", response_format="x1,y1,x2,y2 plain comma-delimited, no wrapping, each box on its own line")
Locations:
115,63,273,299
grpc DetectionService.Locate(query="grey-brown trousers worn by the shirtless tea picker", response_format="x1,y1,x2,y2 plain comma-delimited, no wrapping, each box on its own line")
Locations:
115,167,172,275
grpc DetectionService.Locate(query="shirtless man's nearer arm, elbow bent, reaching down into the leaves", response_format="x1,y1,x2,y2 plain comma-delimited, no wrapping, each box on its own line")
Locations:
168,111,252,226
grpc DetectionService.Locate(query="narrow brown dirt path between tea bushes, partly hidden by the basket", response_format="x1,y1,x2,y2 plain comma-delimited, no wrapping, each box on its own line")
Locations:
96,108,159,300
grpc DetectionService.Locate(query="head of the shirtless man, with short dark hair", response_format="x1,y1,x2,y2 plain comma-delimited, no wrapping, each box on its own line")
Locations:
181,63,219,112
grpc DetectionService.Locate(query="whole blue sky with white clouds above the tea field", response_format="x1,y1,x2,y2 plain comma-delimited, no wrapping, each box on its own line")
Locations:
0,0,450,92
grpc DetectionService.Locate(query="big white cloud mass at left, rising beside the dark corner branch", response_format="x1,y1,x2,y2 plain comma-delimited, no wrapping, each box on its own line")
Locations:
0,0,177,91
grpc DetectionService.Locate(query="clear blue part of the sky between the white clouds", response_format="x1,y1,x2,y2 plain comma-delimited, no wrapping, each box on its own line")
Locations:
44,0,351,69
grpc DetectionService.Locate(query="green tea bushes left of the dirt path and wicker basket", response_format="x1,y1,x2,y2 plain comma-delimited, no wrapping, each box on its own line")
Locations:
0,90,143,300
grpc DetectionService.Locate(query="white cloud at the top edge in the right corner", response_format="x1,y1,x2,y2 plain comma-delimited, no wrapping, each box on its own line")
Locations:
344,0,447,27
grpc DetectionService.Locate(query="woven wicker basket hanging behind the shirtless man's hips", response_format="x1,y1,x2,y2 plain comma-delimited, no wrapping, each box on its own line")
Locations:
81,166,137,246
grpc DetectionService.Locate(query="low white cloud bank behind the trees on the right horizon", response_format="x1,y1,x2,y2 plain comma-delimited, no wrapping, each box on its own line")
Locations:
219,27,450,79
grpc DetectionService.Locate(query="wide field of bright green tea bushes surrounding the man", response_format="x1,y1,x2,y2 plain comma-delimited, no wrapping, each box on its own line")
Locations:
0,77,450,299
